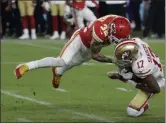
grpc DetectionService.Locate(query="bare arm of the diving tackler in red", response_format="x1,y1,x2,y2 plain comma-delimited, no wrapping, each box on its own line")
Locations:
90,41,114,63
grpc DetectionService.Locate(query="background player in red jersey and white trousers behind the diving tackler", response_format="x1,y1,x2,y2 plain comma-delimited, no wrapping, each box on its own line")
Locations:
66,0,98,29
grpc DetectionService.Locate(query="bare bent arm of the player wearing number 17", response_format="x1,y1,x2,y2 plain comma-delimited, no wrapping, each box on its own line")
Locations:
136,75,160,93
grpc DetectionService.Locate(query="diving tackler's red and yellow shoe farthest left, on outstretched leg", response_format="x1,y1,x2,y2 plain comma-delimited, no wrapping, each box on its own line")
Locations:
14,64,29,79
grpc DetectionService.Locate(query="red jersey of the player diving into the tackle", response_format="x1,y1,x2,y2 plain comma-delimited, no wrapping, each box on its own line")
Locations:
80,15,117,48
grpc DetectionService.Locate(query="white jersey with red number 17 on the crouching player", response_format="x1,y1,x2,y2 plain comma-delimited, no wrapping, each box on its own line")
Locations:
132,38,164,79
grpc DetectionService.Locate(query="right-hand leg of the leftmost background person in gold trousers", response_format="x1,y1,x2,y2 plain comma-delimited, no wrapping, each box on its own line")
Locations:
26,1,37,39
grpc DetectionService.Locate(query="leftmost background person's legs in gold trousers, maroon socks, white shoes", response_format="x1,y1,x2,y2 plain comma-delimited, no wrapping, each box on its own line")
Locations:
18,0,37,39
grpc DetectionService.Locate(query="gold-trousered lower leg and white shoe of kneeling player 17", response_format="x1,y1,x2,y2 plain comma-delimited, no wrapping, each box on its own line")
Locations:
127,90,153,117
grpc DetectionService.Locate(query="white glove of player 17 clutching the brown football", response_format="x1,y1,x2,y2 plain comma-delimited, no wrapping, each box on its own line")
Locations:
119,68,133,80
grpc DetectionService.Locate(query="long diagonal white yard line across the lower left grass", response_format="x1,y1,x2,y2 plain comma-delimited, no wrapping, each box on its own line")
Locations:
1,89,114,122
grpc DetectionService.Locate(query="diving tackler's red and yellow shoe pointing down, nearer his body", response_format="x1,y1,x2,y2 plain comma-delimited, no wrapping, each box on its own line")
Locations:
52,67,62,88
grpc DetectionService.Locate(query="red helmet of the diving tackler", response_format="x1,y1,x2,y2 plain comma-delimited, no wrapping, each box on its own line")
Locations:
108,16,131,44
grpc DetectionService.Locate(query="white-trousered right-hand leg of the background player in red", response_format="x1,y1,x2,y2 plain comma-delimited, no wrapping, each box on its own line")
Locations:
83,7,97,22
